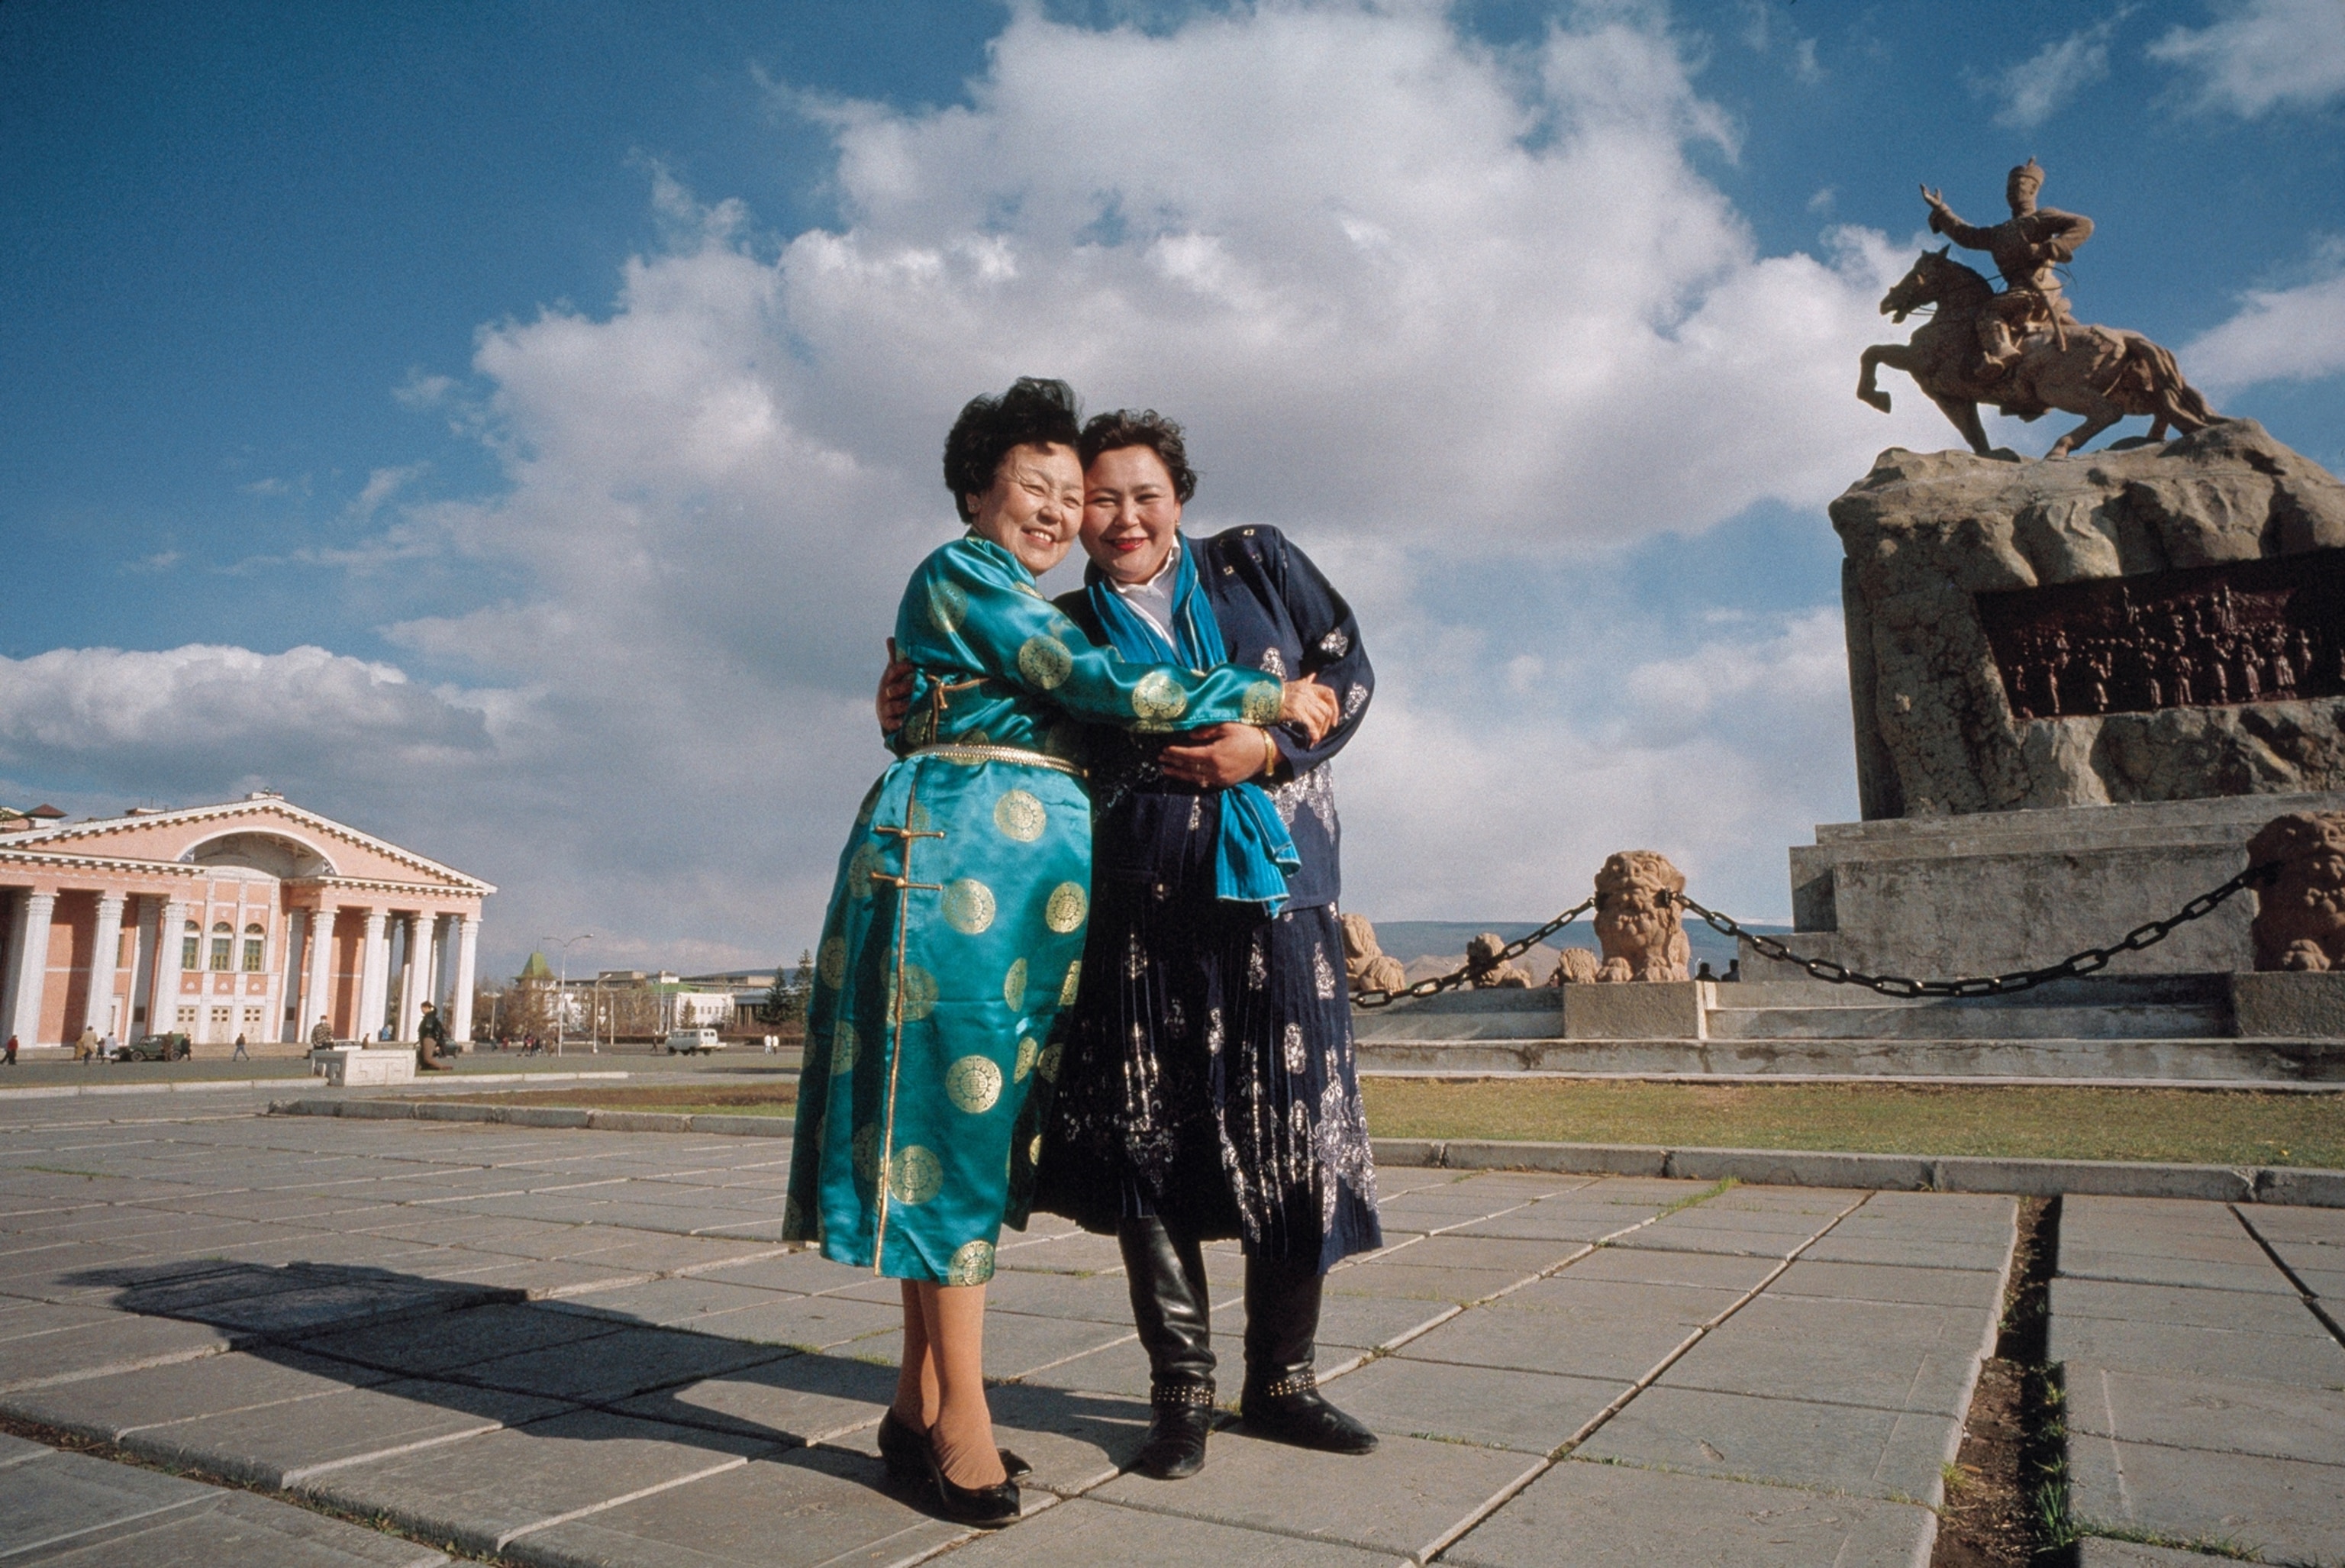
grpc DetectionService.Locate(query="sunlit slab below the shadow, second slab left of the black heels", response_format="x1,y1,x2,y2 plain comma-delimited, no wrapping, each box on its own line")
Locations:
300,1411,772,1552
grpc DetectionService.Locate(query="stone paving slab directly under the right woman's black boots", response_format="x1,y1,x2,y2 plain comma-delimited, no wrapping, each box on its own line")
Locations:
1093,1428,1538,1557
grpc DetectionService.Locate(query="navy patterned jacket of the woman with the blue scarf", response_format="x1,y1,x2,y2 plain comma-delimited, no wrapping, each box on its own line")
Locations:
1055,528,1376,909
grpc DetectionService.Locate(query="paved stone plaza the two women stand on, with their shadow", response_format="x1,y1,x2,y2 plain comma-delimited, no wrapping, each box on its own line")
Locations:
0,1095,2345,1568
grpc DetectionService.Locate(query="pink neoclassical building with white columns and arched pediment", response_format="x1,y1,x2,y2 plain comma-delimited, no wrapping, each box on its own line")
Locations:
0,795,497,1055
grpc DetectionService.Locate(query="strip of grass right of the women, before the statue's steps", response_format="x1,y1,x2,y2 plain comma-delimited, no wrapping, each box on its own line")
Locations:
1360,1078,2345,1167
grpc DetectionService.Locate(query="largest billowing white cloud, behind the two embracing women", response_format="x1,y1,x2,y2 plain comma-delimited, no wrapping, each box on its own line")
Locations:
18,2,1951,963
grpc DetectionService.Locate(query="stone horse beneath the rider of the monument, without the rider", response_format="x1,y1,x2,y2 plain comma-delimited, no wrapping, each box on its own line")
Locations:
1857,246,2221,457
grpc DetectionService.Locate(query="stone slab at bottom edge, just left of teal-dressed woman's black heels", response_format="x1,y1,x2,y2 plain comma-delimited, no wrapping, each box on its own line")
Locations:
507,1448,980,1568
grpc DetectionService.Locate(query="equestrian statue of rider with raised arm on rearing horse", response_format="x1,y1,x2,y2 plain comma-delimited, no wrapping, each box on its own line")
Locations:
1857,157,2221,457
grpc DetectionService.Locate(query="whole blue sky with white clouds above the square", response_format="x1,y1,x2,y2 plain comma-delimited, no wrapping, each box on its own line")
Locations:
0,0,2345,963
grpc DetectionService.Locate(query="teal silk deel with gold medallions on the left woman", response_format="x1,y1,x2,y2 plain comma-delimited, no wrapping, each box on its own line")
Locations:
783,534,1280,1284
